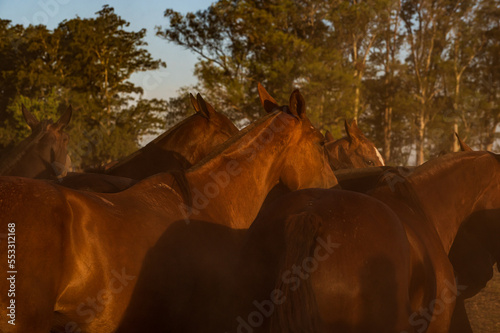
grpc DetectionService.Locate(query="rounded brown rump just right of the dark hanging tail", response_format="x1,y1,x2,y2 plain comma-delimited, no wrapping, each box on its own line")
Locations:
311,191,410,332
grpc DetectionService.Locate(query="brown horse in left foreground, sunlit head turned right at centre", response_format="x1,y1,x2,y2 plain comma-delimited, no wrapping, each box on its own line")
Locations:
0,91,335,332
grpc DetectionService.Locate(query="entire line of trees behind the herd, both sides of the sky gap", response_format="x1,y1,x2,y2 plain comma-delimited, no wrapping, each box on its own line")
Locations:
0,0,500,167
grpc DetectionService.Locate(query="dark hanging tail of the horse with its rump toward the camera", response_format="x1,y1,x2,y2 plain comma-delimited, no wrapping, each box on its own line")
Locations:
270,212,323,333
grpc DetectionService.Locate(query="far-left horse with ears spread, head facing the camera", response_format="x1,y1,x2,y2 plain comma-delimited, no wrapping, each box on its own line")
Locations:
0,105,72,179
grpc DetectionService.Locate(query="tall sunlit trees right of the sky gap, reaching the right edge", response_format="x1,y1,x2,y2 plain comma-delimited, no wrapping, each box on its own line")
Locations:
161,0,500,164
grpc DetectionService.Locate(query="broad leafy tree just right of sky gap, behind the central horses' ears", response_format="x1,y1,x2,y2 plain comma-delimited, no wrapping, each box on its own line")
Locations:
157,0,346,134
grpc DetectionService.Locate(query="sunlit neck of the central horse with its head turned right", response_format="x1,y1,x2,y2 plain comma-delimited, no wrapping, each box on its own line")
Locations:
186,113,292,228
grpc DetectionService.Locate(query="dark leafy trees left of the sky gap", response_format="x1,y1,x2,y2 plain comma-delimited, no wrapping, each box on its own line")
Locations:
0,6,167,168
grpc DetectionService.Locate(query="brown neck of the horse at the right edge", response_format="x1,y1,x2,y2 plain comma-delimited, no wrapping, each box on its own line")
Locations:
392,152,500,253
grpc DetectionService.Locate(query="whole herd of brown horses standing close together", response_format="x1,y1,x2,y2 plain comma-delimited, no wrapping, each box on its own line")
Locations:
0,84,500,333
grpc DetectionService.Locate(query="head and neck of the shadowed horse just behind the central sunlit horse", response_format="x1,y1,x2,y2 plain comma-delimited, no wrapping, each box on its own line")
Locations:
106,94,238,179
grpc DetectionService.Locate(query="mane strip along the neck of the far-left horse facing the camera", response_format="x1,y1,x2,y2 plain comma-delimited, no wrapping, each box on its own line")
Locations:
0,120,53,175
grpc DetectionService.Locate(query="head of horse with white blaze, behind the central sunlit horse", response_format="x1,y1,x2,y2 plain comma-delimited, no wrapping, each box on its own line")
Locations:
325,121,385,170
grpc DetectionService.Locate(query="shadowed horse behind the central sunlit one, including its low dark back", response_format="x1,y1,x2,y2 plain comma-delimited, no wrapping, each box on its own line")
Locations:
59,94,238,193
